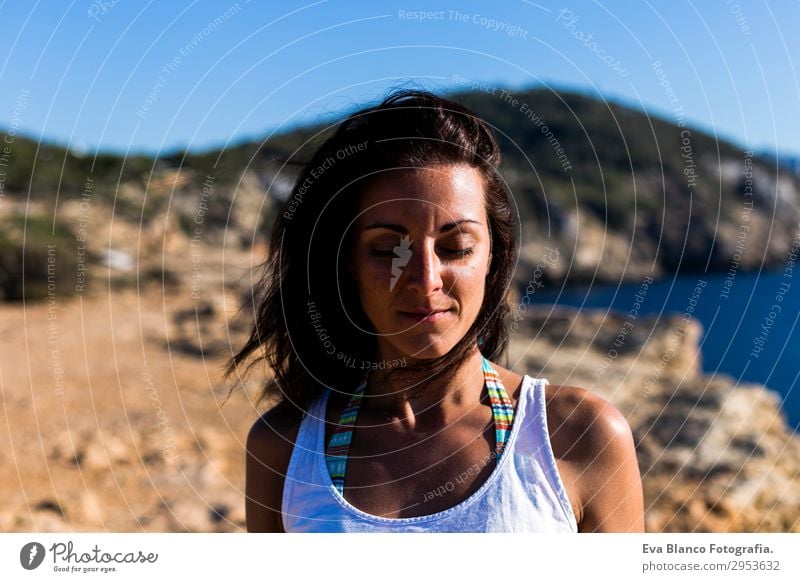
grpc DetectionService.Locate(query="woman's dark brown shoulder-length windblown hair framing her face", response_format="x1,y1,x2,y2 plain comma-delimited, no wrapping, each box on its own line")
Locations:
227,90,517,411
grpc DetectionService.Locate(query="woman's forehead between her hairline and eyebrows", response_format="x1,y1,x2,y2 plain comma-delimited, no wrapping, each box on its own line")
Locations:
358,165,485,222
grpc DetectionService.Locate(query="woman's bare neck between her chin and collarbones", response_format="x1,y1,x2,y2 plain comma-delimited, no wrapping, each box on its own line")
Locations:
361,347,484,428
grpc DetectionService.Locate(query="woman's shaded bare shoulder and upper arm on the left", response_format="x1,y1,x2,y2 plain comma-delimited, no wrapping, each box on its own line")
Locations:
245,402,302,532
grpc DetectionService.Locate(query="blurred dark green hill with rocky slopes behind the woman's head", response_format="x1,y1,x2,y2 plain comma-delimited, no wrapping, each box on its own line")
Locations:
0,88,800,302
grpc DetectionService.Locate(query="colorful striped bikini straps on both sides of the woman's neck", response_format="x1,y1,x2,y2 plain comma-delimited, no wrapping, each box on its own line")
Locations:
325,358,514,495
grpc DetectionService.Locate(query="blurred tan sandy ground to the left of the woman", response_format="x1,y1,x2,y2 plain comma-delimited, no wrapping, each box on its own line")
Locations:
0,270,257,531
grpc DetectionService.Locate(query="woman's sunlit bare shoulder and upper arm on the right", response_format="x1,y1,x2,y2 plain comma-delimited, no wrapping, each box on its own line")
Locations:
545,385,644,531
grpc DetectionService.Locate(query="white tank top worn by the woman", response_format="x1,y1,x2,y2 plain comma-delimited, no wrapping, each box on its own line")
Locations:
281,376,578,533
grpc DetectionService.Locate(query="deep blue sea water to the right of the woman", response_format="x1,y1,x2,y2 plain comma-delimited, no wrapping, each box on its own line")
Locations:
532,269,800,430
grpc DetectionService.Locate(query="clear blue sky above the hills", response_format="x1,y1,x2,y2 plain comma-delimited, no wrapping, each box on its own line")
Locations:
0,0,800,155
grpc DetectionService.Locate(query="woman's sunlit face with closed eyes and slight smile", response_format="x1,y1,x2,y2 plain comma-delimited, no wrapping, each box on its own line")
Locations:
348,165,491,363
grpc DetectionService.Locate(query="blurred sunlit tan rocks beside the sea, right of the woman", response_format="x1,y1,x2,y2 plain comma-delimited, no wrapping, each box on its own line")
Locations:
510,306,800,532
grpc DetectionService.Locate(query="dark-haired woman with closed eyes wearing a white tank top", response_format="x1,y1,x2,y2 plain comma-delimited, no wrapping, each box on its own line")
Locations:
229,91,643,532
